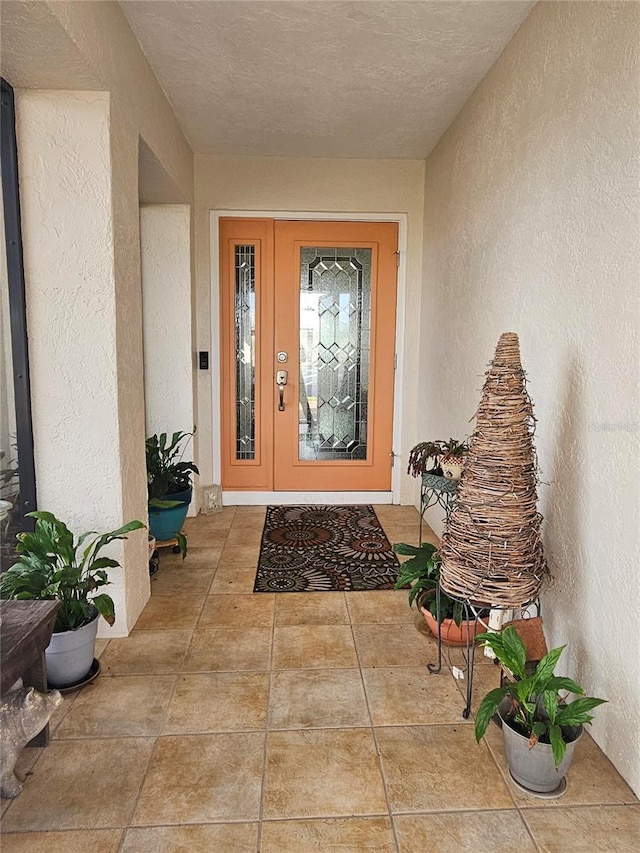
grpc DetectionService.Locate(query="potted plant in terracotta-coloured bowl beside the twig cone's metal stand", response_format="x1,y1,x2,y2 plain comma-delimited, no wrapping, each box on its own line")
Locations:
393,542,488,646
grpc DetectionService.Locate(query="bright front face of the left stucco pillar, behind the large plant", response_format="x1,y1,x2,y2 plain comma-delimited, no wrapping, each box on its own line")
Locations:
16,92,140,633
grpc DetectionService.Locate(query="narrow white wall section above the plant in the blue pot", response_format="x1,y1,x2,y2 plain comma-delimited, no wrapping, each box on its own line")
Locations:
140,204,196,512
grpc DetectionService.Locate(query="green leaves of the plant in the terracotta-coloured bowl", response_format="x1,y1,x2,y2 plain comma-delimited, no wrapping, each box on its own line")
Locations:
393,542,463,626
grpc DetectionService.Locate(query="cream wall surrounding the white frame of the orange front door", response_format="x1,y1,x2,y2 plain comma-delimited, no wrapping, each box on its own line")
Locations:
195,155,424,502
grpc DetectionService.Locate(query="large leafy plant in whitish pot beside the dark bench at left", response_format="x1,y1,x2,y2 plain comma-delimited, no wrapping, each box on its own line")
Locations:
0,512,144,687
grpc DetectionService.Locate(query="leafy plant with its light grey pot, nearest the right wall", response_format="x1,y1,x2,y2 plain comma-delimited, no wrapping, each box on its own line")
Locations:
475,626,606,796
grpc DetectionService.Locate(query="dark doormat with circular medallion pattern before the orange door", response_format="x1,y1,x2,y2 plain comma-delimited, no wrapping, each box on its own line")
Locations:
253,506,400,592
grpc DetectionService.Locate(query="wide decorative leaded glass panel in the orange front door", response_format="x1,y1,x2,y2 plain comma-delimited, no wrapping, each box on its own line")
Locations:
298,247,371,460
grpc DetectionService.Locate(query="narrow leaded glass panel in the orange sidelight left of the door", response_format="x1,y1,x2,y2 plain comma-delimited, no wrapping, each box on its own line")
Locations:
235,246,256,459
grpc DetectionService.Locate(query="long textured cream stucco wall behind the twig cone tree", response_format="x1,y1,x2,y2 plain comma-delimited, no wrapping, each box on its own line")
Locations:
418,3,640,793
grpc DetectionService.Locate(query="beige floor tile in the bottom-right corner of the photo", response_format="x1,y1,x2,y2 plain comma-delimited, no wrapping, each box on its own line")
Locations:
522,799,640,853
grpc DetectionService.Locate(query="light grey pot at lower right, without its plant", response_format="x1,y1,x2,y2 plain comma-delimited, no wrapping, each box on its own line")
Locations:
498,711,583,794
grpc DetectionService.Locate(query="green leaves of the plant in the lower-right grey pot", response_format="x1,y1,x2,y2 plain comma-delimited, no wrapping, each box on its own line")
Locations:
476,625,606,767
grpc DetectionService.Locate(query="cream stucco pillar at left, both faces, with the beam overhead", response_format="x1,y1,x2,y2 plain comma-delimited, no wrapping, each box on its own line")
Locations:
2,2,193,636
